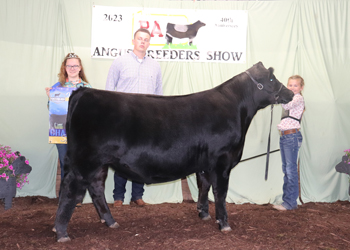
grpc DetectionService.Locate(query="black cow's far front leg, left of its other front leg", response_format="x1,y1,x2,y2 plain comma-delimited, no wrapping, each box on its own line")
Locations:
196,172,210,220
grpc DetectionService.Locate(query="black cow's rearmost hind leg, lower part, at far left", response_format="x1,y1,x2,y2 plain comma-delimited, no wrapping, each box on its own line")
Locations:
53,170,86,242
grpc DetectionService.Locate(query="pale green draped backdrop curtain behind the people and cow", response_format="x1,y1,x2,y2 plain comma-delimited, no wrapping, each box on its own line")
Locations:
0,0,350,204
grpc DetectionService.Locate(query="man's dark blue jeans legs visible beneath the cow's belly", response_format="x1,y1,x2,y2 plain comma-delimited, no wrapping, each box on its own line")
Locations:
113,173,144,201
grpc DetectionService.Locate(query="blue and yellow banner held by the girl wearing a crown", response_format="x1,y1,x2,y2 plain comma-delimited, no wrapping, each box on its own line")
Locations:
49,88,76,144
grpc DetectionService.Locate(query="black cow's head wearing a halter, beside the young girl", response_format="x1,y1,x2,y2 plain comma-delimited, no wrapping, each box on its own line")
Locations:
246,62,294,108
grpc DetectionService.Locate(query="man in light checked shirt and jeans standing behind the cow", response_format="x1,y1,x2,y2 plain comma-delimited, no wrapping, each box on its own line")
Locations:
106,28,163,207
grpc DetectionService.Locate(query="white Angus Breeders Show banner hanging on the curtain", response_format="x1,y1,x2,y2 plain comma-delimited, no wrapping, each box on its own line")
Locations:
91,5,248,63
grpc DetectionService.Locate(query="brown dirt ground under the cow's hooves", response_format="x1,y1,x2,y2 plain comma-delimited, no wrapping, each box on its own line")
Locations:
0,196,350,250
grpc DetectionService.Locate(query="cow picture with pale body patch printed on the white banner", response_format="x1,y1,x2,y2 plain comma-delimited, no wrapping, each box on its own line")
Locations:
165,21,205,45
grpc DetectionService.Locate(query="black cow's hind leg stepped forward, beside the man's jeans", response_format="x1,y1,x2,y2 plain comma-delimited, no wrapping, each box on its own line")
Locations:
88,167,119,228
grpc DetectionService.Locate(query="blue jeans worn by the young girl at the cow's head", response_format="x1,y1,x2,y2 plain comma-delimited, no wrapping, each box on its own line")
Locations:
280,131,303,210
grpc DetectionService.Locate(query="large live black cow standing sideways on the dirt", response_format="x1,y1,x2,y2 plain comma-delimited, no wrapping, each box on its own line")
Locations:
54,62,293,242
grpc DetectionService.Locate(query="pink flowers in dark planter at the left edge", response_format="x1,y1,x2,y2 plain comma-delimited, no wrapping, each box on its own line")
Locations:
0,145,32,210
